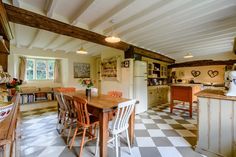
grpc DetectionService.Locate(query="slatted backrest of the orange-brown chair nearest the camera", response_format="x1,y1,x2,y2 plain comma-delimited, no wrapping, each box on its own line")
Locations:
73,96,90,126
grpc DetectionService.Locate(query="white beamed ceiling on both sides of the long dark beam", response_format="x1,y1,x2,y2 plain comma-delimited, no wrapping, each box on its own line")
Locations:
4,0,236,62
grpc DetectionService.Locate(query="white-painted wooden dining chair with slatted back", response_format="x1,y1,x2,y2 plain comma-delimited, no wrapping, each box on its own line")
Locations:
108,100,136,157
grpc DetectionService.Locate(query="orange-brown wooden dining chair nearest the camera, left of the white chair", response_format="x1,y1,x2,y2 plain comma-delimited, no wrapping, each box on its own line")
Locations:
70,96,99,157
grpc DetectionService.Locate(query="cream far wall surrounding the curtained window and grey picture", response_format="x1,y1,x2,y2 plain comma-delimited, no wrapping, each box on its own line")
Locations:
8,45,95,89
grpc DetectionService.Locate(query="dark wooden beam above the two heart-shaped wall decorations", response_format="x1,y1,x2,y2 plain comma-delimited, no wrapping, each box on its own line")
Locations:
168,60,236,68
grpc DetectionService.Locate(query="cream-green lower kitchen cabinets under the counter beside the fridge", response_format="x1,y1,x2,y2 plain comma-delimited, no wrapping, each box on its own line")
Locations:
148,85,170,107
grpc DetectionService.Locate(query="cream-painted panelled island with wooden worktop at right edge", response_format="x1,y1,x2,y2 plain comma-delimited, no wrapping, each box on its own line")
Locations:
196,89,236,157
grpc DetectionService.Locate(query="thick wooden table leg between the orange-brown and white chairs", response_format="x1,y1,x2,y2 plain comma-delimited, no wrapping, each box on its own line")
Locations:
99,112,108,157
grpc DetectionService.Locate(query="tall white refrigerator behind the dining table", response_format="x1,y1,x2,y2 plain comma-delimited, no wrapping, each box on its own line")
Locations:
133,61,148,114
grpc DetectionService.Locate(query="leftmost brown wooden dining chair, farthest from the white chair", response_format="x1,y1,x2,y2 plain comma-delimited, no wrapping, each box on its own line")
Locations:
55,92,68,134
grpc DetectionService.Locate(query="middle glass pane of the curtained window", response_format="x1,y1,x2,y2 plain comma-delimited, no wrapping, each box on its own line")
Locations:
36,60,47,80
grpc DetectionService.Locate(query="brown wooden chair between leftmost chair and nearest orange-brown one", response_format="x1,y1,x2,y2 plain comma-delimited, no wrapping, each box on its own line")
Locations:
63,95,77,144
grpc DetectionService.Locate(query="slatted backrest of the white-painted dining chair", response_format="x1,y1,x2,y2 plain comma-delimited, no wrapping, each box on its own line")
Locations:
112,100,136,131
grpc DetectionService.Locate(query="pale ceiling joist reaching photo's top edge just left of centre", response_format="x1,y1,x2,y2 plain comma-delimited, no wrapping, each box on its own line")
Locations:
71,0,95,25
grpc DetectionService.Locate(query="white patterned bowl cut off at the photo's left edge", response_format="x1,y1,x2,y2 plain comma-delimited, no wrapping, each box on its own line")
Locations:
0,102,14,122
